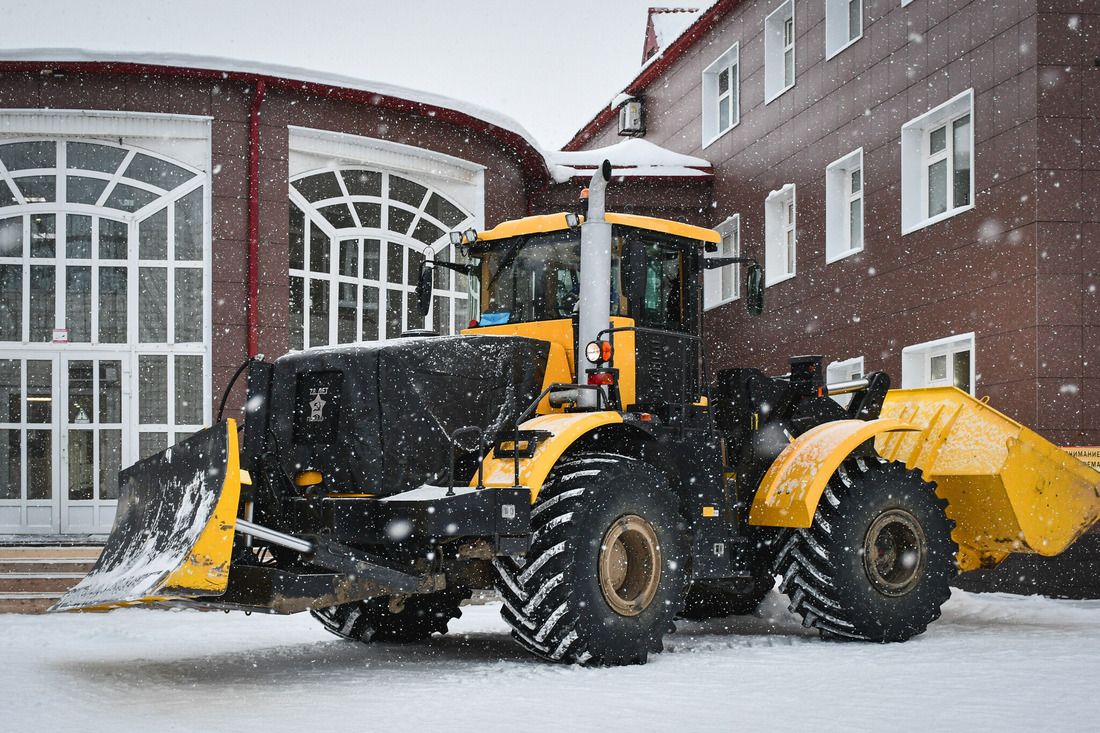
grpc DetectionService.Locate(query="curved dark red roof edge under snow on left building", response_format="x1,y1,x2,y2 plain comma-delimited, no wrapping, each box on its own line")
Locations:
0,61,551,185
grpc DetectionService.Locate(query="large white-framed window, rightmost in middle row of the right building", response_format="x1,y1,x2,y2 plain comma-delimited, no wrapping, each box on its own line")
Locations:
901,89,977,234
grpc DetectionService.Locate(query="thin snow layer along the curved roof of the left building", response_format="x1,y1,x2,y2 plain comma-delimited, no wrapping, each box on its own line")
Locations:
0,48,546,165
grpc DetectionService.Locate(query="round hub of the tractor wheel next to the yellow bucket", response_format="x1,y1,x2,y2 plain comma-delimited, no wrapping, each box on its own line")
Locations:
864,510,928,597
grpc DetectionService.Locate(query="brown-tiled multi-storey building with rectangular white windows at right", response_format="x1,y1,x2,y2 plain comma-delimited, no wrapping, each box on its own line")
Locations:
567,0,1100,445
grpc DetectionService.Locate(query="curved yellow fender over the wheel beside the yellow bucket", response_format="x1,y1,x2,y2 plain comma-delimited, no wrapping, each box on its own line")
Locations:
749,418,916,527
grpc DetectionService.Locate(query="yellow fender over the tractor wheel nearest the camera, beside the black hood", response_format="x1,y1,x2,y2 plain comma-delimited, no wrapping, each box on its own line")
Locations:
470,412,623,504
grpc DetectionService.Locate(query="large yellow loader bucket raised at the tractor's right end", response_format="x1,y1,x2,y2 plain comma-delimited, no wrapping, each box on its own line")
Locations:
876,387,1100,570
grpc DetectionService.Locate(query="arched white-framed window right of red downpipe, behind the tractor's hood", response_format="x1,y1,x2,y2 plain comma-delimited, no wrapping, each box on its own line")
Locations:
289,167,473,349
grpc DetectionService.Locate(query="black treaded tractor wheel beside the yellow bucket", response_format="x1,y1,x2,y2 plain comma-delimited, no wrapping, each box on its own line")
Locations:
776,458,958,642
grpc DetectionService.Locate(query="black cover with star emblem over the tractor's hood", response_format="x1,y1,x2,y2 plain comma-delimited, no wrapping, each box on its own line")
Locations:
270,336,550,495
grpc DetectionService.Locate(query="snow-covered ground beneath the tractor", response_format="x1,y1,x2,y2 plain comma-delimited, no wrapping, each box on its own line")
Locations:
0,590,1100,733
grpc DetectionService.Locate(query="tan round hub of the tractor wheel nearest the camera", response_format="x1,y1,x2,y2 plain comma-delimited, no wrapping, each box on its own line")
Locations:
600,514,661,616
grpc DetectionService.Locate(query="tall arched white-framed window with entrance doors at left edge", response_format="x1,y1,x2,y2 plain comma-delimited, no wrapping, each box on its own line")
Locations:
0,139,209,532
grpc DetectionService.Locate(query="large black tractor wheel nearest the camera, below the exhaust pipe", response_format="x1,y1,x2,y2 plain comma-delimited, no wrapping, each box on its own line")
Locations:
494,453,688,666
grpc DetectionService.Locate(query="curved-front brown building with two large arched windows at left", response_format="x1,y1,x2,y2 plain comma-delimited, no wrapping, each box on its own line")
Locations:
0,59,549,536
